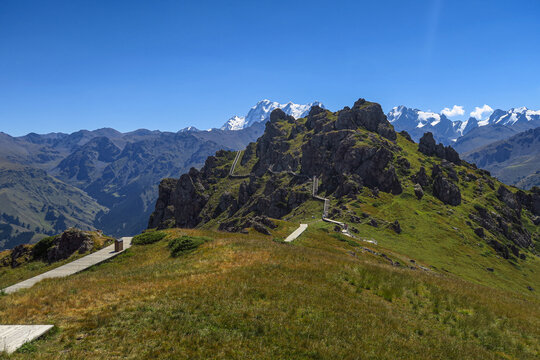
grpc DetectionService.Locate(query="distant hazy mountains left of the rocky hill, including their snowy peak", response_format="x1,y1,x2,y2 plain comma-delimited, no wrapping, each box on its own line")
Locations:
0,100,320,250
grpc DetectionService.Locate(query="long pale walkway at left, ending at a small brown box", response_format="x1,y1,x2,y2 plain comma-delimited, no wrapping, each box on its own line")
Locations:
3,237,132,294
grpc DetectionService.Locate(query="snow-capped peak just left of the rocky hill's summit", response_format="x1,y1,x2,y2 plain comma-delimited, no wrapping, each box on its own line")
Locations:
220,99,324,130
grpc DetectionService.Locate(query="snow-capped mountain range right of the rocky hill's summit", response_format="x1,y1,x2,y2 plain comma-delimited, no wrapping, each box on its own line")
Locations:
387,105,540,151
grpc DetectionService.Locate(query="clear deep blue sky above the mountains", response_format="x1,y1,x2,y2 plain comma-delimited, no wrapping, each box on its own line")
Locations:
0,0,540,135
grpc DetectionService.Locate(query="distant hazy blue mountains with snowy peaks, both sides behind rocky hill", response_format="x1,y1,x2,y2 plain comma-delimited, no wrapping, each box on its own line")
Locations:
0,100,540,249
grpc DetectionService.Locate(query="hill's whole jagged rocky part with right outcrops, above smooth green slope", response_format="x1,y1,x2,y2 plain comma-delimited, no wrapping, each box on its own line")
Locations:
149,99,540,259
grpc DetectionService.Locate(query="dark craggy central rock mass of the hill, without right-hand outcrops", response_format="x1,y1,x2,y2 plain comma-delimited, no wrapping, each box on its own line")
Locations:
149,99,402,228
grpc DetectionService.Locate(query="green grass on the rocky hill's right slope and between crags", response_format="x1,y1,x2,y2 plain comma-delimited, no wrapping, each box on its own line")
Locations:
175,111,540,296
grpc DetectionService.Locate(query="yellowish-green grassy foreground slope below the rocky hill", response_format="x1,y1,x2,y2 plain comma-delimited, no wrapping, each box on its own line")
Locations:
0,223,540,359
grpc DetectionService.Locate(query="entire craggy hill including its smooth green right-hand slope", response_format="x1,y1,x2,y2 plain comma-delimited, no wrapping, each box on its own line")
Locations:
149,99,540,290
